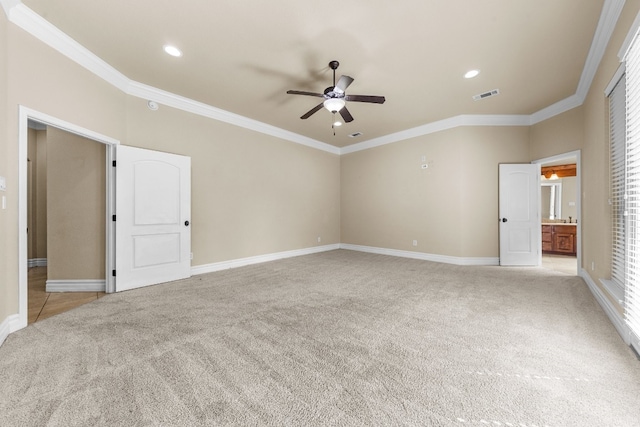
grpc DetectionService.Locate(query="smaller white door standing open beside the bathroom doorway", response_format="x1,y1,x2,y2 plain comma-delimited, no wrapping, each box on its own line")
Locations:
498,164,542,266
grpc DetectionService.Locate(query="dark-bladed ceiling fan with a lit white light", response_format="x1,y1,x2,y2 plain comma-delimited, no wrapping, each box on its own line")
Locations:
287,61,385,123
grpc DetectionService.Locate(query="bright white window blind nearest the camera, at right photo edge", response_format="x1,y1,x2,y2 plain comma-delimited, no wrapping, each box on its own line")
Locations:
625,37,640,351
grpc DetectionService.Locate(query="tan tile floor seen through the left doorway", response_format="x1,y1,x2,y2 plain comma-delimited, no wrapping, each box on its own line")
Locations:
27,267,105,323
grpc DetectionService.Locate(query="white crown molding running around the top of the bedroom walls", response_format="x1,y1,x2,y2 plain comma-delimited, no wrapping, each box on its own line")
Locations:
0,0,624,155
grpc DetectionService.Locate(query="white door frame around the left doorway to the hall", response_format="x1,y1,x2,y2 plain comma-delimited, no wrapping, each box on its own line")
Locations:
17,105,120,329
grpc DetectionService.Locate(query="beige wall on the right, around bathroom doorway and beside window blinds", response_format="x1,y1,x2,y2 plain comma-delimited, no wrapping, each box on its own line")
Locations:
531,0,640,311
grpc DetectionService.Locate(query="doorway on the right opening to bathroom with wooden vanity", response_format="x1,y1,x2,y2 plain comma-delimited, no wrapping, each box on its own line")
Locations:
533,150,581,275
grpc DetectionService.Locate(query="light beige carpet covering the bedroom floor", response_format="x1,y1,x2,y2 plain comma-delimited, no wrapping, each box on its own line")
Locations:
0,250,640,427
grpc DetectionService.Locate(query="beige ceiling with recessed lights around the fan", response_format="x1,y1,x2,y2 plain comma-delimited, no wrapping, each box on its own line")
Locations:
17,0,605,147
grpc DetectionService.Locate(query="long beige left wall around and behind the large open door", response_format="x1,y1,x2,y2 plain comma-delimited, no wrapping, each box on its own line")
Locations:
0,11,340,320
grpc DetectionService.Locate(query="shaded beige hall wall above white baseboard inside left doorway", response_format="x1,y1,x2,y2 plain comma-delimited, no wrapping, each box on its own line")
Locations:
47,127,106,280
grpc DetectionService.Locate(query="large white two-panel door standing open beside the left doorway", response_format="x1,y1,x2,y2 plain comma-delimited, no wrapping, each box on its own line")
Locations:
115,145,191,292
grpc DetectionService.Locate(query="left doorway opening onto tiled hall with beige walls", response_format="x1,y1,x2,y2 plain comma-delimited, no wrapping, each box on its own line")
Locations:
27,120,106,323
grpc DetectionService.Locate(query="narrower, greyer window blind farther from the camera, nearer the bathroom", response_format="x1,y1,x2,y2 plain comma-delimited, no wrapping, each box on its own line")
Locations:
609,74,627,293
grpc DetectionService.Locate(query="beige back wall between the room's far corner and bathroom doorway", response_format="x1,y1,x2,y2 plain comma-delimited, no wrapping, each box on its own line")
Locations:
341,123,529,257
